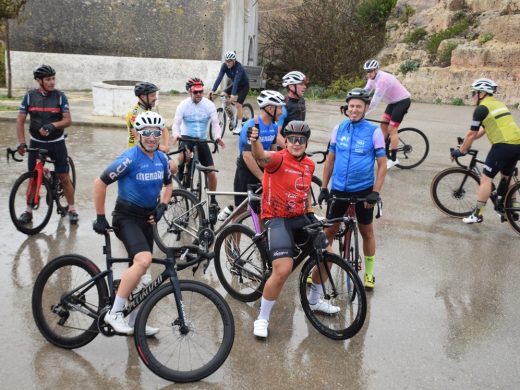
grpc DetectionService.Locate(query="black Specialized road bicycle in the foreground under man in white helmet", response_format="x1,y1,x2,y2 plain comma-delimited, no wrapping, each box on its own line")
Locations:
32,231,235,382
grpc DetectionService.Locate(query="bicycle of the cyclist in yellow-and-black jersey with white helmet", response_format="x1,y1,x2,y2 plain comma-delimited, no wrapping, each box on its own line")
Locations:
430,138,520,234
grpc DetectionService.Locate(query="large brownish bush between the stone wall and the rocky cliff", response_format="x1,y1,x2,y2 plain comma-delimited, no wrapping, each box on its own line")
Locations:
259,0,395,86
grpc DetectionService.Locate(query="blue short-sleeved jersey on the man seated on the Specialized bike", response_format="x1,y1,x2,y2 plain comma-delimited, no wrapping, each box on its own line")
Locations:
101,146,172,209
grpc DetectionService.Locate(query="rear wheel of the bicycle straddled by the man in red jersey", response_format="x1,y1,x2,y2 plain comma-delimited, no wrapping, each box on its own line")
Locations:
213,224,268,302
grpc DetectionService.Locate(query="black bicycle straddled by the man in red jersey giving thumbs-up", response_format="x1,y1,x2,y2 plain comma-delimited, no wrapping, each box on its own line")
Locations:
214,195,367,340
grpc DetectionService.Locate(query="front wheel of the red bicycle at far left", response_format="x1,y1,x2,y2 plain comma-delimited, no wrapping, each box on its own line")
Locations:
9,171,53,235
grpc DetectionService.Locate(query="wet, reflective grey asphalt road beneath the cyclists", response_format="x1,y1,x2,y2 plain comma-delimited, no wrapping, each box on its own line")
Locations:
0,103,520,389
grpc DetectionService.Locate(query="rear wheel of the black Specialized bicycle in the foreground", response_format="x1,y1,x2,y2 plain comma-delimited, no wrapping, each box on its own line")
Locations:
32,255,110,349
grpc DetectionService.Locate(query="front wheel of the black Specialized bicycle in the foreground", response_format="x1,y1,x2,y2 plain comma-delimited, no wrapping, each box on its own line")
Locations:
134,280,235,382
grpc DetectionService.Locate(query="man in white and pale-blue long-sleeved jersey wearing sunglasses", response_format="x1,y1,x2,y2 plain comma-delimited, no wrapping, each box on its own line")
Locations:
172,77,226,221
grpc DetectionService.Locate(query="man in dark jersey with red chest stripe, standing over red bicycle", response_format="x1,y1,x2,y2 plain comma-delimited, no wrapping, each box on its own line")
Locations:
16,65,79,224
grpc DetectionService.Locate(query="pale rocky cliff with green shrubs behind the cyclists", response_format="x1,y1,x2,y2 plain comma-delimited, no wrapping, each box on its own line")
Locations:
378,0,520,108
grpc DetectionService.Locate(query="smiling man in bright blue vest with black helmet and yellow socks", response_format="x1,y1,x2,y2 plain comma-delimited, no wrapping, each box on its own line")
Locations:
318,88,387,289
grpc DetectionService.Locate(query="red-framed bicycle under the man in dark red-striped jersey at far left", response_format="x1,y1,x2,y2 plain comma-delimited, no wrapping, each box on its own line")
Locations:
7,148,76,235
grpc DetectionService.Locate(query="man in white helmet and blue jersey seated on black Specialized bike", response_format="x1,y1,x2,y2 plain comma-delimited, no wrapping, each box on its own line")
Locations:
93,111,172,336
